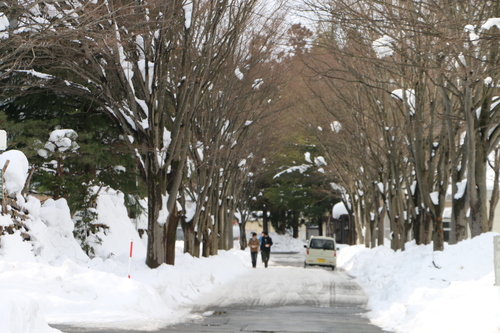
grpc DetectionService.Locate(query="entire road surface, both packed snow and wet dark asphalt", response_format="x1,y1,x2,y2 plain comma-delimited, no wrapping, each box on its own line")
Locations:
52,253,382,333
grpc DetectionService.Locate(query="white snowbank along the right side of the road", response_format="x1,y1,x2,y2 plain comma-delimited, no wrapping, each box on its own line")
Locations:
338,233,500,333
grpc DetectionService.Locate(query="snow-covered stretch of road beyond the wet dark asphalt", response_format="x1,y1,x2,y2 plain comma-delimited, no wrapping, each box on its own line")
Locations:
189,254,366,312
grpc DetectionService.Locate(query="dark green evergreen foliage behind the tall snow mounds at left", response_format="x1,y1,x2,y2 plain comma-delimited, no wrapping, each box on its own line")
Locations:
0,90,146,256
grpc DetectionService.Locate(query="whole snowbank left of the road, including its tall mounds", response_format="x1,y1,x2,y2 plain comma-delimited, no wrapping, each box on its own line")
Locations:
0,151,251,333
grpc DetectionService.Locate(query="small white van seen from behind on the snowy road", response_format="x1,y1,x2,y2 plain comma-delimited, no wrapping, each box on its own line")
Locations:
304,236,338,270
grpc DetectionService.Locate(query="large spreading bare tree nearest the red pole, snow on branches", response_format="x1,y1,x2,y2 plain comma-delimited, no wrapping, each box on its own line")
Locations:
0,0,266,267
